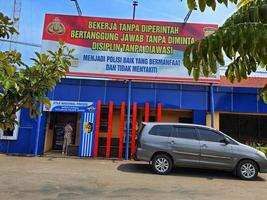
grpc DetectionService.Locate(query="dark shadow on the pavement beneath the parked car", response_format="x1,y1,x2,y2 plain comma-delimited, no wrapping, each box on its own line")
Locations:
117,163,266,181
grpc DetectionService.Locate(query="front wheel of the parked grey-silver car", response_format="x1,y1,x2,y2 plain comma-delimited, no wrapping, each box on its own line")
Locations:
236,160,259,180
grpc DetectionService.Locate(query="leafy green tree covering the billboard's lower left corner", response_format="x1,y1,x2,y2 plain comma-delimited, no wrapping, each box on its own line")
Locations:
0,13,73,130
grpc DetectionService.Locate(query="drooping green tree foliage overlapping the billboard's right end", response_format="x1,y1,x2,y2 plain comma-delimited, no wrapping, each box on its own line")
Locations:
184,0,267,103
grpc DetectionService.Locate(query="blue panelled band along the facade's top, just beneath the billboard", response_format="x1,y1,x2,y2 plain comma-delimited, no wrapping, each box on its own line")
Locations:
49,79,267,113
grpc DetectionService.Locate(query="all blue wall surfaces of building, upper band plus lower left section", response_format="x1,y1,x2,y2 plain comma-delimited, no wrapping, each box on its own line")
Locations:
0,79,267,154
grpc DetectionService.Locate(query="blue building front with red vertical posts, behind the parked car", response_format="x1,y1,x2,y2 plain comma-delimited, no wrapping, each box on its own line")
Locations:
0,78,267,158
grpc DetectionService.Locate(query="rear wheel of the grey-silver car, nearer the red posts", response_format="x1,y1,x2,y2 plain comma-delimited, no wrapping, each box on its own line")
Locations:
152,154,173,175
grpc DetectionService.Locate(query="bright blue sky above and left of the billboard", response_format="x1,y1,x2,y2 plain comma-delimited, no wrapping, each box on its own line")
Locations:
0,0,236,63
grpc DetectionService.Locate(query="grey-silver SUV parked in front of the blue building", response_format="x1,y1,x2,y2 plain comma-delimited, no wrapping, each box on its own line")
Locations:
135,122,267,180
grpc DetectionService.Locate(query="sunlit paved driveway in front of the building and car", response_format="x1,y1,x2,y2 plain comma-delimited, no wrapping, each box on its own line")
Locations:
0,154,267,200
